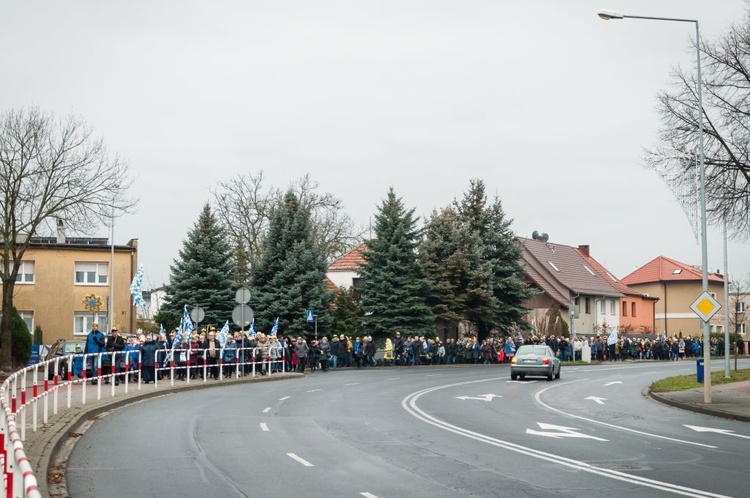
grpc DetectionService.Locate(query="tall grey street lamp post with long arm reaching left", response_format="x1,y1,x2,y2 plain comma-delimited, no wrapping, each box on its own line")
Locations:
598,10,711,403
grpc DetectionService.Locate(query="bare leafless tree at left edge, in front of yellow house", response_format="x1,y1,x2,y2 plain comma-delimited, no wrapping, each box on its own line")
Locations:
0,108,137,372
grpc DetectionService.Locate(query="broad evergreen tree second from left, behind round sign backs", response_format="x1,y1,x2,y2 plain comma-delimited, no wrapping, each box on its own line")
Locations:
251,190,333,335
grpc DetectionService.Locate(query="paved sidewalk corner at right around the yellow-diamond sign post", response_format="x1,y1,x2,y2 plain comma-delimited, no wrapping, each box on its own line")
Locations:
648,381,750,422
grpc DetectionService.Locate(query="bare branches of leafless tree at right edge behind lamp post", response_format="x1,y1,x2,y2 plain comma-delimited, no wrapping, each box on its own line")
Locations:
646,11,750,238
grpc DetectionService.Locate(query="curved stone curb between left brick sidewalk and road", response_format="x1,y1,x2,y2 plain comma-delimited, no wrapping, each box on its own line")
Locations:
35,373,304,498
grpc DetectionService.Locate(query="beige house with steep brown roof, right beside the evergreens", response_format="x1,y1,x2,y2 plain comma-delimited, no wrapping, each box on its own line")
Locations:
516,237,624,336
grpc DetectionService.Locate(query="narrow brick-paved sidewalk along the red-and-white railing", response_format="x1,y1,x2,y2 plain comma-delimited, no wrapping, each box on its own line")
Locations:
17,373,303,497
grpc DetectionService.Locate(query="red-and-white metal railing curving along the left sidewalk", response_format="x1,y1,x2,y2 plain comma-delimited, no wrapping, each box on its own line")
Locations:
0,347,287,498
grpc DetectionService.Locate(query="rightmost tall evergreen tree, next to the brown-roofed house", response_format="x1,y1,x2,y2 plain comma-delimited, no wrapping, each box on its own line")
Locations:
454,180,534,339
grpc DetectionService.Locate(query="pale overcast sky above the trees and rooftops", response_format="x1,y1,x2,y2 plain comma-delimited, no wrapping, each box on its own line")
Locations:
0,0,750,288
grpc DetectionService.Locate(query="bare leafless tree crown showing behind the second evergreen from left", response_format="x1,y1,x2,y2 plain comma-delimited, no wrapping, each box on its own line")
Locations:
212,171,365,282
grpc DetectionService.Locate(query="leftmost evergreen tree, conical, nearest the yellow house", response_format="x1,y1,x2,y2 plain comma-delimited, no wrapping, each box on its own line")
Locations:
163,204,236,327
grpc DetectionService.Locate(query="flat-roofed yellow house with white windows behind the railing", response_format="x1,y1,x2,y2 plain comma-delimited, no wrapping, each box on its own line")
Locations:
4,237,138,344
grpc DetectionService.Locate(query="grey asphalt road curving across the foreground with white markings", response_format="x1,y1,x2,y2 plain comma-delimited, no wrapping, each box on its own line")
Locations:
67,362,750,498
